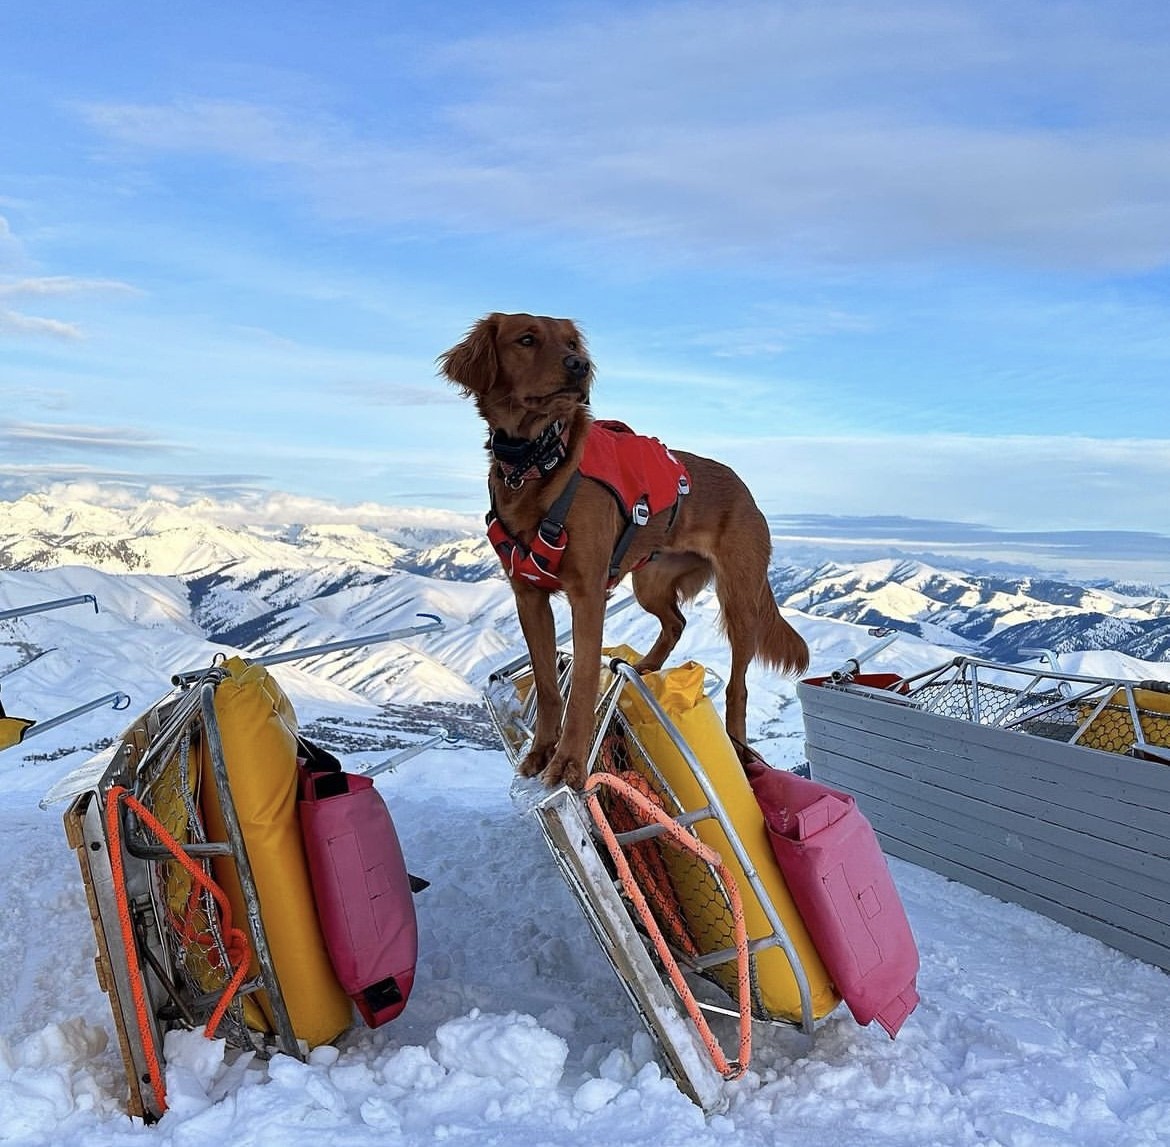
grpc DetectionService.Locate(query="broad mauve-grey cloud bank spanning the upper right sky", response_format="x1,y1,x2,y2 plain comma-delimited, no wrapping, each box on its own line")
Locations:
75,2,1170,272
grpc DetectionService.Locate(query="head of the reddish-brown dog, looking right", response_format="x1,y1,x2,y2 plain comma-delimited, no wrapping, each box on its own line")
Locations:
439,314,593,438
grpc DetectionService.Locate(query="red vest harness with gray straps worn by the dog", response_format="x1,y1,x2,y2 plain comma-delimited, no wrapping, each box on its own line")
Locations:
488,421,690,590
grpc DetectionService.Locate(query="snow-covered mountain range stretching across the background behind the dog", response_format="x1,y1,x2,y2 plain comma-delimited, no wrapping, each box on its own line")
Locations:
0,494,1170,772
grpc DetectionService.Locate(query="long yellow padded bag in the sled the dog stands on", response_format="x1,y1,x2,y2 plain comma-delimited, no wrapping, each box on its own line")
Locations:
619,661,840,1022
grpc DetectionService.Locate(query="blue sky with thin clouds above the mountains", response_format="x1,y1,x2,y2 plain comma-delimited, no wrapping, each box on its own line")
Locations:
0,0,1170,544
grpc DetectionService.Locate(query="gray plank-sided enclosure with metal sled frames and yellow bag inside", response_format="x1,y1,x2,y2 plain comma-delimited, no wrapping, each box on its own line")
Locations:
797,638,1170,970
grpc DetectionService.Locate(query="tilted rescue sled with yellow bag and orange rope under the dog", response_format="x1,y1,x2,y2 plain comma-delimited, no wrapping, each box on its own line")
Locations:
486,636,917,1112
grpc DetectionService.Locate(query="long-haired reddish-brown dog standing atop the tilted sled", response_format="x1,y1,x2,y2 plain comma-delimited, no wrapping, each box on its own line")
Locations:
438,314,808,789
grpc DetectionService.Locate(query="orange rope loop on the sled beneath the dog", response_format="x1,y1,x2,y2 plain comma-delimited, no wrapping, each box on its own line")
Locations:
584,772,751,1079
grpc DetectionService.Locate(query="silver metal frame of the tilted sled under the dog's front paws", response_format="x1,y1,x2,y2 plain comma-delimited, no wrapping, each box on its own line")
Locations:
484,652,814,1112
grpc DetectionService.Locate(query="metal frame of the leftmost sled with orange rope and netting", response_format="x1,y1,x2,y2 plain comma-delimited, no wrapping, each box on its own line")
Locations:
64,614,442,1119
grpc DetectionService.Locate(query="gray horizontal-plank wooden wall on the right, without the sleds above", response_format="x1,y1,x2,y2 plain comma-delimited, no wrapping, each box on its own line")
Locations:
797,684,1170,970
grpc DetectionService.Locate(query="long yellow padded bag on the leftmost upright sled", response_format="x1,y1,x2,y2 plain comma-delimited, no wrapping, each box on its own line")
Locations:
201,658,353,1046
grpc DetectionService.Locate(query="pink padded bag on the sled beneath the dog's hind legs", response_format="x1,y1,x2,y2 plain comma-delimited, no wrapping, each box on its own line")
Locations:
744,758,918,1038
